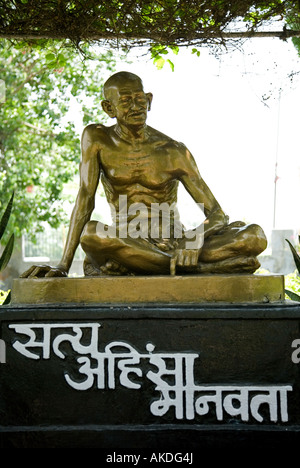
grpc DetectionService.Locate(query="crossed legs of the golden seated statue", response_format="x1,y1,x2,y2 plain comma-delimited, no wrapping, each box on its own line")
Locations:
80,221,267,276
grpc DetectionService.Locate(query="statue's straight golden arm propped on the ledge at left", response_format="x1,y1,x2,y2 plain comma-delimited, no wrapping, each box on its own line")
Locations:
21,127,100,278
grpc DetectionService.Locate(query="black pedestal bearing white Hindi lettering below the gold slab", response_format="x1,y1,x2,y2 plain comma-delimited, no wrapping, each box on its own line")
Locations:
0,302,300,452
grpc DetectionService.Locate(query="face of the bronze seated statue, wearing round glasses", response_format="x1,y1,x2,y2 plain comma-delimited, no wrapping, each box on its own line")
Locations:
109,80,152,126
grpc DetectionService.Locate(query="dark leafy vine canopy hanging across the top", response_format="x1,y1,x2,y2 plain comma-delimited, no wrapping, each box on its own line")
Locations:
0,0,299,52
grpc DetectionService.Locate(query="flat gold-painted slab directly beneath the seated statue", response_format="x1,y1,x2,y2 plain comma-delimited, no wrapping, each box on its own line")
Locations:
12,274,284,305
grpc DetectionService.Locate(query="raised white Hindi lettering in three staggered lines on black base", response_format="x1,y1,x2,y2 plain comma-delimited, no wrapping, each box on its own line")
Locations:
9,322,293,423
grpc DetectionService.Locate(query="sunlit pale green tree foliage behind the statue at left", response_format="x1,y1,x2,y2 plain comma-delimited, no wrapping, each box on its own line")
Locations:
0,40,115,241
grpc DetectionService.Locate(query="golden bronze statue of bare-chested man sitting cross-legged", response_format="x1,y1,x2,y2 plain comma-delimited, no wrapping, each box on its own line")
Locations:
21,72,267,278
